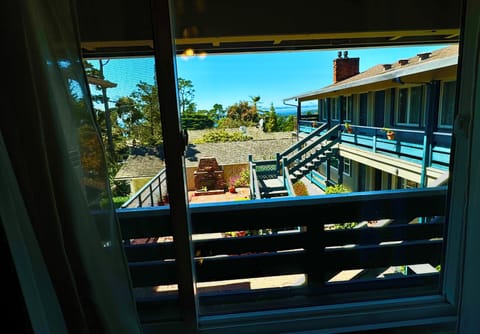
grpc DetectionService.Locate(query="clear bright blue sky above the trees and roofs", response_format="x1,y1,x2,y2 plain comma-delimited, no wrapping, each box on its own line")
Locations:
89,45,456,110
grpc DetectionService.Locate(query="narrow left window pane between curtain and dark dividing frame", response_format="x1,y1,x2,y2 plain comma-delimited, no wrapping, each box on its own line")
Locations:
84,57,180,320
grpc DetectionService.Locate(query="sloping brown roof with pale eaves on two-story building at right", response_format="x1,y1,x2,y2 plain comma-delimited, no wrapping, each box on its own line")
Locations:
284,44,458,101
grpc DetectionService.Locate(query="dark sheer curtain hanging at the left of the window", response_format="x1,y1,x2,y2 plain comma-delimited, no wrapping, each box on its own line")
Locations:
0,0,141,334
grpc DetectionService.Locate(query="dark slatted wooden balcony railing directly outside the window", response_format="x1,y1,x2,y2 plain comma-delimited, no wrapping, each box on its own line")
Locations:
117,187,447,318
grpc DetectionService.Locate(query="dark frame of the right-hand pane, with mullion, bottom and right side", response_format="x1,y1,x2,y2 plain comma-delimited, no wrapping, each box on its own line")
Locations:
145,0,480,333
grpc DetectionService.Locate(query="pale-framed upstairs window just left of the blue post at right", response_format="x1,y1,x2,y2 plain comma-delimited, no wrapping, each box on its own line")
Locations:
397,86,423,126
